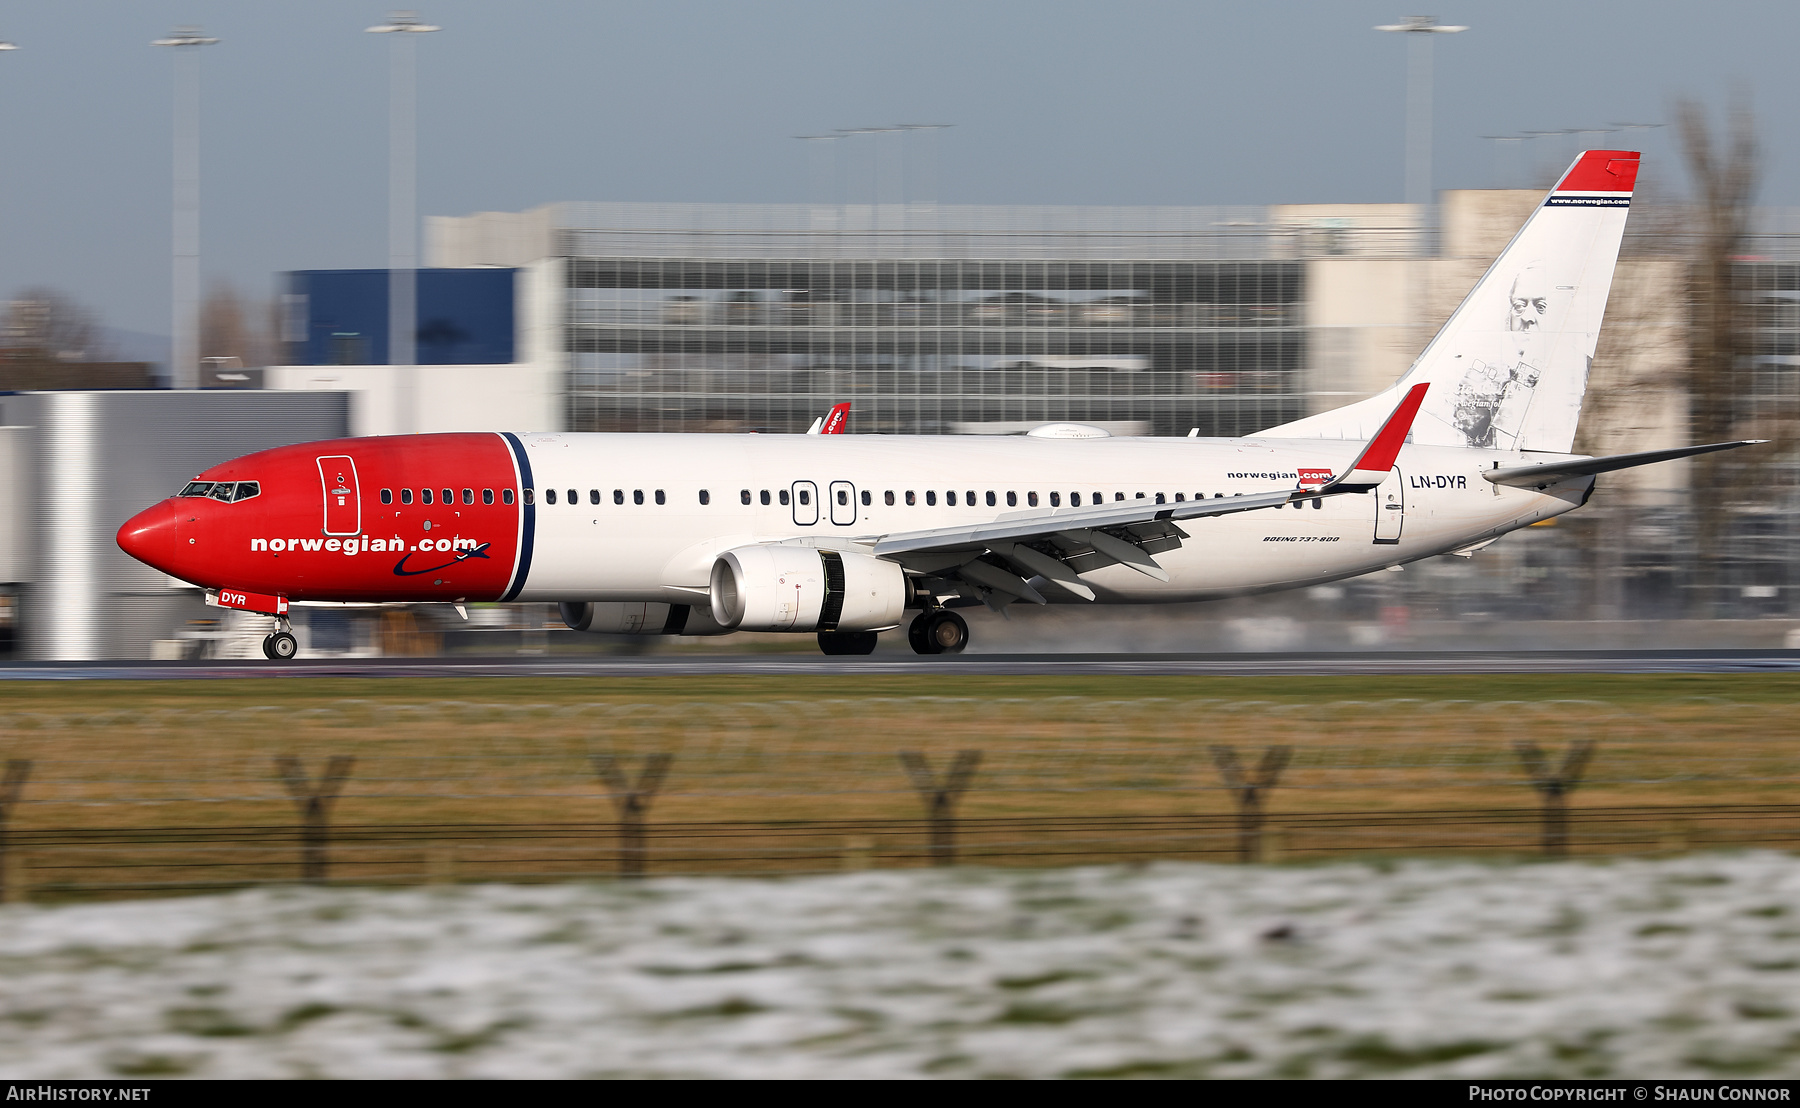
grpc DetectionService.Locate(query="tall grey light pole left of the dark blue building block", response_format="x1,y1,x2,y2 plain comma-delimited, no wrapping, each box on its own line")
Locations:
151,27,218,389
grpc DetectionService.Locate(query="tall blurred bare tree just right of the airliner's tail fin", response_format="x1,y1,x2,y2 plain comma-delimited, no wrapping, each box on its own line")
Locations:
1676,94,1764,613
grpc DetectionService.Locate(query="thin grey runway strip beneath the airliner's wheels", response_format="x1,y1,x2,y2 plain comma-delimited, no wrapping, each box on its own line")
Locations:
0,649,1800,680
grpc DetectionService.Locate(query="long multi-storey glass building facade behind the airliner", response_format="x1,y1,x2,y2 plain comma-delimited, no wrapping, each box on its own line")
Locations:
560,205,1307,435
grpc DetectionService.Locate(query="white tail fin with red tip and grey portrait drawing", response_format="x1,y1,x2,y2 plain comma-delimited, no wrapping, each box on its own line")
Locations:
1260,149,1638,453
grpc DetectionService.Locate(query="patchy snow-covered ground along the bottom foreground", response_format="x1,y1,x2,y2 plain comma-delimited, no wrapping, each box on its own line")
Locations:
0,854,1800,1077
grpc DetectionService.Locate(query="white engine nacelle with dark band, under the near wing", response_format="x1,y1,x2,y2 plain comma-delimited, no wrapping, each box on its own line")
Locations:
713,545,907,631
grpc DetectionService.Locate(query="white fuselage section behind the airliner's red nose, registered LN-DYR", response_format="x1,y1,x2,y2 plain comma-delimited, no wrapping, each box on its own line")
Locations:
517,433,1593,604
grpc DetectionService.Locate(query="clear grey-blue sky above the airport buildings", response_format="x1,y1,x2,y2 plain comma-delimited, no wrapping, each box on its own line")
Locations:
0,0,1800,335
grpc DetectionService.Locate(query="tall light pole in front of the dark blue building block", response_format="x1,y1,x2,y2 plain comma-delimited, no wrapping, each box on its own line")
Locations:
367,11,439,435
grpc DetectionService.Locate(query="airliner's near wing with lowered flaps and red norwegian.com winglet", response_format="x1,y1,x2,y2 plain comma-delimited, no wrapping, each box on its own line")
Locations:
856,385,1427,608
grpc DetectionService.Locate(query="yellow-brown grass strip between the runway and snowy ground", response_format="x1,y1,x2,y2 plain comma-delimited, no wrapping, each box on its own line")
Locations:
0,675,1800,892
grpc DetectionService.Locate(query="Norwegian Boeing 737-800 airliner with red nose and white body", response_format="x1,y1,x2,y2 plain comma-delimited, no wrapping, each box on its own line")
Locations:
119,151,1744,658
